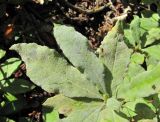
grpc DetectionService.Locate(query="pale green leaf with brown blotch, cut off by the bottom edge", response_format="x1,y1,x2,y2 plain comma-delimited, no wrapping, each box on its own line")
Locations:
43,95,128,122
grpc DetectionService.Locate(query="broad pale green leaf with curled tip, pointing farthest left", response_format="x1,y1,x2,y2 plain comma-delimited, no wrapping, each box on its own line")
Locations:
11,43,101,98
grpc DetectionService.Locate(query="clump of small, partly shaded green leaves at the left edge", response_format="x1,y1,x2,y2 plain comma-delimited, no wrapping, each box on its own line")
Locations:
0,47,35,122
